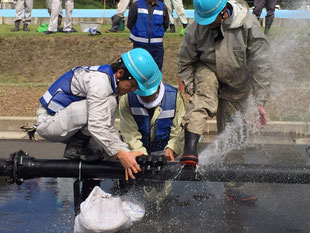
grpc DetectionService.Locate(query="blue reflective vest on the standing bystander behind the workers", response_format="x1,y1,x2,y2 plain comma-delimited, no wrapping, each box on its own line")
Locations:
129,0,165,44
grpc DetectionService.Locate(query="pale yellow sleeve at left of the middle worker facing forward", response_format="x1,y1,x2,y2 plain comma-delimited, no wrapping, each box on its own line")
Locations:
119,95,147,155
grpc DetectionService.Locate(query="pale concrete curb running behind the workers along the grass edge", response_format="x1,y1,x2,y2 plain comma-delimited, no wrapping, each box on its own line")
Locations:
0,117,310,140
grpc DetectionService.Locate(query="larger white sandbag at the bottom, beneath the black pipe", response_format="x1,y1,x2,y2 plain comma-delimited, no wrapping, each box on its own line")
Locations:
74,186,132,233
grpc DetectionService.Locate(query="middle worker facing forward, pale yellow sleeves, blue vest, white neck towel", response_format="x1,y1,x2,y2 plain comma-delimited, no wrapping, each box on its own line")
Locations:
119,80,185,161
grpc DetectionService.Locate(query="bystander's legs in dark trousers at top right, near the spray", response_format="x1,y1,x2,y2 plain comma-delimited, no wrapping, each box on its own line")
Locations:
253,0,278,36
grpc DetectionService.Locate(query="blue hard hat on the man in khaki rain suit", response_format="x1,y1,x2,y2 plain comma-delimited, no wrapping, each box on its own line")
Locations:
194,0,227,25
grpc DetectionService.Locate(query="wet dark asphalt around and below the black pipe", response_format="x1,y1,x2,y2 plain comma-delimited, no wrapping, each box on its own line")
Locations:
0,141,310,233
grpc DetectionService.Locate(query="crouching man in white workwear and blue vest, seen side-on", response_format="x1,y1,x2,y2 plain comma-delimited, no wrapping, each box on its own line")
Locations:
36,48,161,179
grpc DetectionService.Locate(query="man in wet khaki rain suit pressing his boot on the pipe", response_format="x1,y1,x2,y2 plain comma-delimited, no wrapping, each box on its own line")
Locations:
178,0,272,202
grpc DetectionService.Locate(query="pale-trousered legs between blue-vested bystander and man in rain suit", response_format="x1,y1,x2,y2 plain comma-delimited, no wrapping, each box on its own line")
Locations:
164,0,188,36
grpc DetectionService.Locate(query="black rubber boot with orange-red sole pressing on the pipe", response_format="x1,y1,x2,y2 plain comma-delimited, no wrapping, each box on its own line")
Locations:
180,129,200,166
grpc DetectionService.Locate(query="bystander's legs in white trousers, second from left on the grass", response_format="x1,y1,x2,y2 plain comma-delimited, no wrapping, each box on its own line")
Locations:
45,0,74,34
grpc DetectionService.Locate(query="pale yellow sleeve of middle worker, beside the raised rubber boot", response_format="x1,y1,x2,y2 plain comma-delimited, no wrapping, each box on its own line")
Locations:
165,92,185,160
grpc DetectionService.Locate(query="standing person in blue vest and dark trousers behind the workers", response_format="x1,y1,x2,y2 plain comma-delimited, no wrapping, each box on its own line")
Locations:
127,0,169,70
